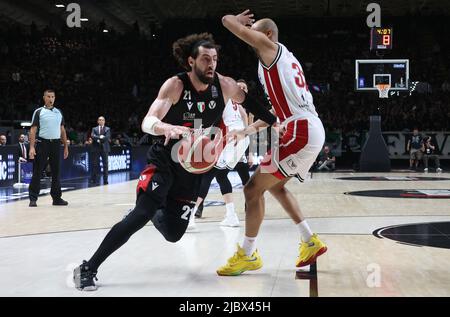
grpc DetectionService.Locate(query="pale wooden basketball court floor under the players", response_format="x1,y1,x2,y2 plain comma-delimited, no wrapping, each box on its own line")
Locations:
0,173,450,297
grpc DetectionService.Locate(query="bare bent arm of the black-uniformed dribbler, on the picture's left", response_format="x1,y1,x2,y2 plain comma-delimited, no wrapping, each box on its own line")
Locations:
142,77,190,144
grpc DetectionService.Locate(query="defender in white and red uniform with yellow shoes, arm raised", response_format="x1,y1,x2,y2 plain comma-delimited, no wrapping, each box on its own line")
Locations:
217,10,327,275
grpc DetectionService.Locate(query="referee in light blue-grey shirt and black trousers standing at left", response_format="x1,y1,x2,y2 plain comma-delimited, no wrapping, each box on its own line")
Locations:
28,89,69,207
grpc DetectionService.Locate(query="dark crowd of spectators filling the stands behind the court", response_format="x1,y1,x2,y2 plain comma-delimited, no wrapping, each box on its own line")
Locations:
0,17,450,148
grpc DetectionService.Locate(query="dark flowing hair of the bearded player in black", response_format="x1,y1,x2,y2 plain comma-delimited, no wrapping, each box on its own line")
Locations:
172,33,220,71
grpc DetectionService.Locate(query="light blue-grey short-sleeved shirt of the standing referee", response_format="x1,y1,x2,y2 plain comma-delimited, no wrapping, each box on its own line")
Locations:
31,107,64,140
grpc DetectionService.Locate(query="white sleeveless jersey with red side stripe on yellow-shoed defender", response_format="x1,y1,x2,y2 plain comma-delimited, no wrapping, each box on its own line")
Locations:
258,43,318,123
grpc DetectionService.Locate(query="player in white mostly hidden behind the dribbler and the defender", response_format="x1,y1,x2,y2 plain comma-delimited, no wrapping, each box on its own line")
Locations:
188,79,252,231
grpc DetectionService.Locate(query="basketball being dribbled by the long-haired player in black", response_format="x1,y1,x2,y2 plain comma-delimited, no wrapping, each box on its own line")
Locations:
177,134,222,174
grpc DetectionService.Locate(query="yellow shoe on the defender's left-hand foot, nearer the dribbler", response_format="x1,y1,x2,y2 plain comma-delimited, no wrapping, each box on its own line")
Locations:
217,244,263,276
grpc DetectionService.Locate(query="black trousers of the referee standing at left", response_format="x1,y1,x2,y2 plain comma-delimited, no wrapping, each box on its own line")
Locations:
28,139,61,201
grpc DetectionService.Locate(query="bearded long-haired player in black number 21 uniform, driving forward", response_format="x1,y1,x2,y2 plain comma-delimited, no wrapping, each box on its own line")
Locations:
74,33,276,291
